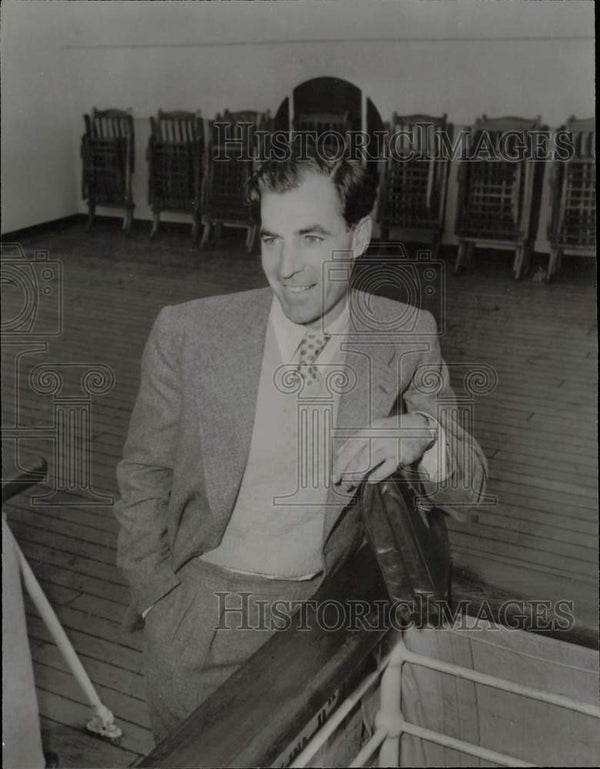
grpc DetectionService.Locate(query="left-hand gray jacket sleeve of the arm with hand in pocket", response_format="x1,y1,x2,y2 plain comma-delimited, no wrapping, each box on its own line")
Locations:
114,307,181,614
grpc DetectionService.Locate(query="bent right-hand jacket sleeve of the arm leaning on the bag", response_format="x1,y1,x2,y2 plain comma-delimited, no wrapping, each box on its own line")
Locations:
402,312,488,520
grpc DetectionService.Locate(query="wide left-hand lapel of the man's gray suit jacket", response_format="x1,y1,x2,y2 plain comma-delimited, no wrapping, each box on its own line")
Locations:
196,289,273,525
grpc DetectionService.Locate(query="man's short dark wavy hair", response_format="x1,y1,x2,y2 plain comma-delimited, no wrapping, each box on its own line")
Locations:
247,153,377,227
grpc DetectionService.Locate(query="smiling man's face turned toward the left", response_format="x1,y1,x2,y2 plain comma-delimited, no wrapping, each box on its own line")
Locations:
260,173,370,328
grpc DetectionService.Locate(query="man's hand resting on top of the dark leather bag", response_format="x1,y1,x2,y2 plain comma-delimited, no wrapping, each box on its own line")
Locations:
333,414,436,491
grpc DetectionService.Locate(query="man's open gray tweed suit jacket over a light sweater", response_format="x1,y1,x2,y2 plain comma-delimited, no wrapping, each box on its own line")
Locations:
115,288,487,626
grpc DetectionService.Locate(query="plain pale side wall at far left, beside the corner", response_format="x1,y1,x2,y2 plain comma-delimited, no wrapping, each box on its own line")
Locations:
1,0,78,232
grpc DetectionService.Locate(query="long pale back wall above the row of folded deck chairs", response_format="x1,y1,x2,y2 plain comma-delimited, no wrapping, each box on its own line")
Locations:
1,0,594,244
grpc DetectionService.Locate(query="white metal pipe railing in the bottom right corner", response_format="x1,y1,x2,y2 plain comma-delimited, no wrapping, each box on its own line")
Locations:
291,641,600,767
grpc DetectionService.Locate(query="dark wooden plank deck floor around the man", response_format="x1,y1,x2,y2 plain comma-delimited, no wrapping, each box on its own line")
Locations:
3,222,597,767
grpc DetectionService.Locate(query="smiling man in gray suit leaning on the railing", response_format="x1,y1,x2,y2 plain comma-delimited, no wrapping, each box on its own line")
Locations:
115,148,486,739
